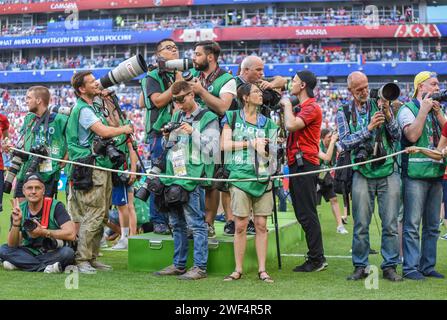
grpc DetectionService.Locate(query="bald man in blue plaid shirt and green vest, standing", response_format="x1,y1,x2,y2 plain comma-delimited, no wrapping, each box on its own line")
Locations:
337,71,402,281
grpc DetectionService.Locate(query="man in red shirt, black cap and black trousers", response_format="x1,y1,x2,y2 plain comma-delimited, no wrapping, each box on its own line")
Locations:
282,70,327,272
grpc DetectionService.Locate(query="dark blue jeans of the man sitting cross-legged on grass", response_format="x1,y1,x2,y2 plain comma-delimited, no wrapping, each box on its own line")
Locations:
0,244,75,272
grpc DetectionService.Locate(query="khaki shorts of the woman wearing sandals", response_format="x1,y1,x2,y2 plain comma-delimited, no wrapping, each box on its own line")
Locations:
230,186,273,217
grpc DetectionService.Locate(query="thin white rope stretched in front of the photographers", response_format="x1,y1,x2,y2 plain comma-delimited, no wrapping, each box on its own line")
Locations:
10,147,440,182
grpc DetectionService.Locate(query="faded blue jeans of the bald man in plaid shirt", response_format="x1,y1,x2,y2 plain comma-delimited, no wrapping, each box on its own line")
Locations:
352,171,402,270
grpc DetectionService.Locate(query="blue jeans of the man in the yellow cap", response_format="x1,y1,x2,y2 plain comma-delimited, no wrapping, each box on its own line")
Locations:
403,178,442,275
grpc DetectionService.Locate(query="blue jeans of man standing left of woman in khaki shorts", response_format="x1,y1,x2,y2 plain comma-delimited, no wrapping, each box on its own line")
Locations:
169,187,208,270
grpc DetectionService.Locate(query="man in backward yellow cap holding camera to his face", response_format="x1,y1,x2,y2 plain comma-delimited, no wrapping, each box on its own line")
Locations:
398,71,446,280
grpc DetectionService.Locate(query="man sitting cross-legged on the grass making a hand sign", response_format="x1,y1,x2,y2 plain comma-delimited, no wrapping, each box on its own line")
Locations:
0,174,76,273
